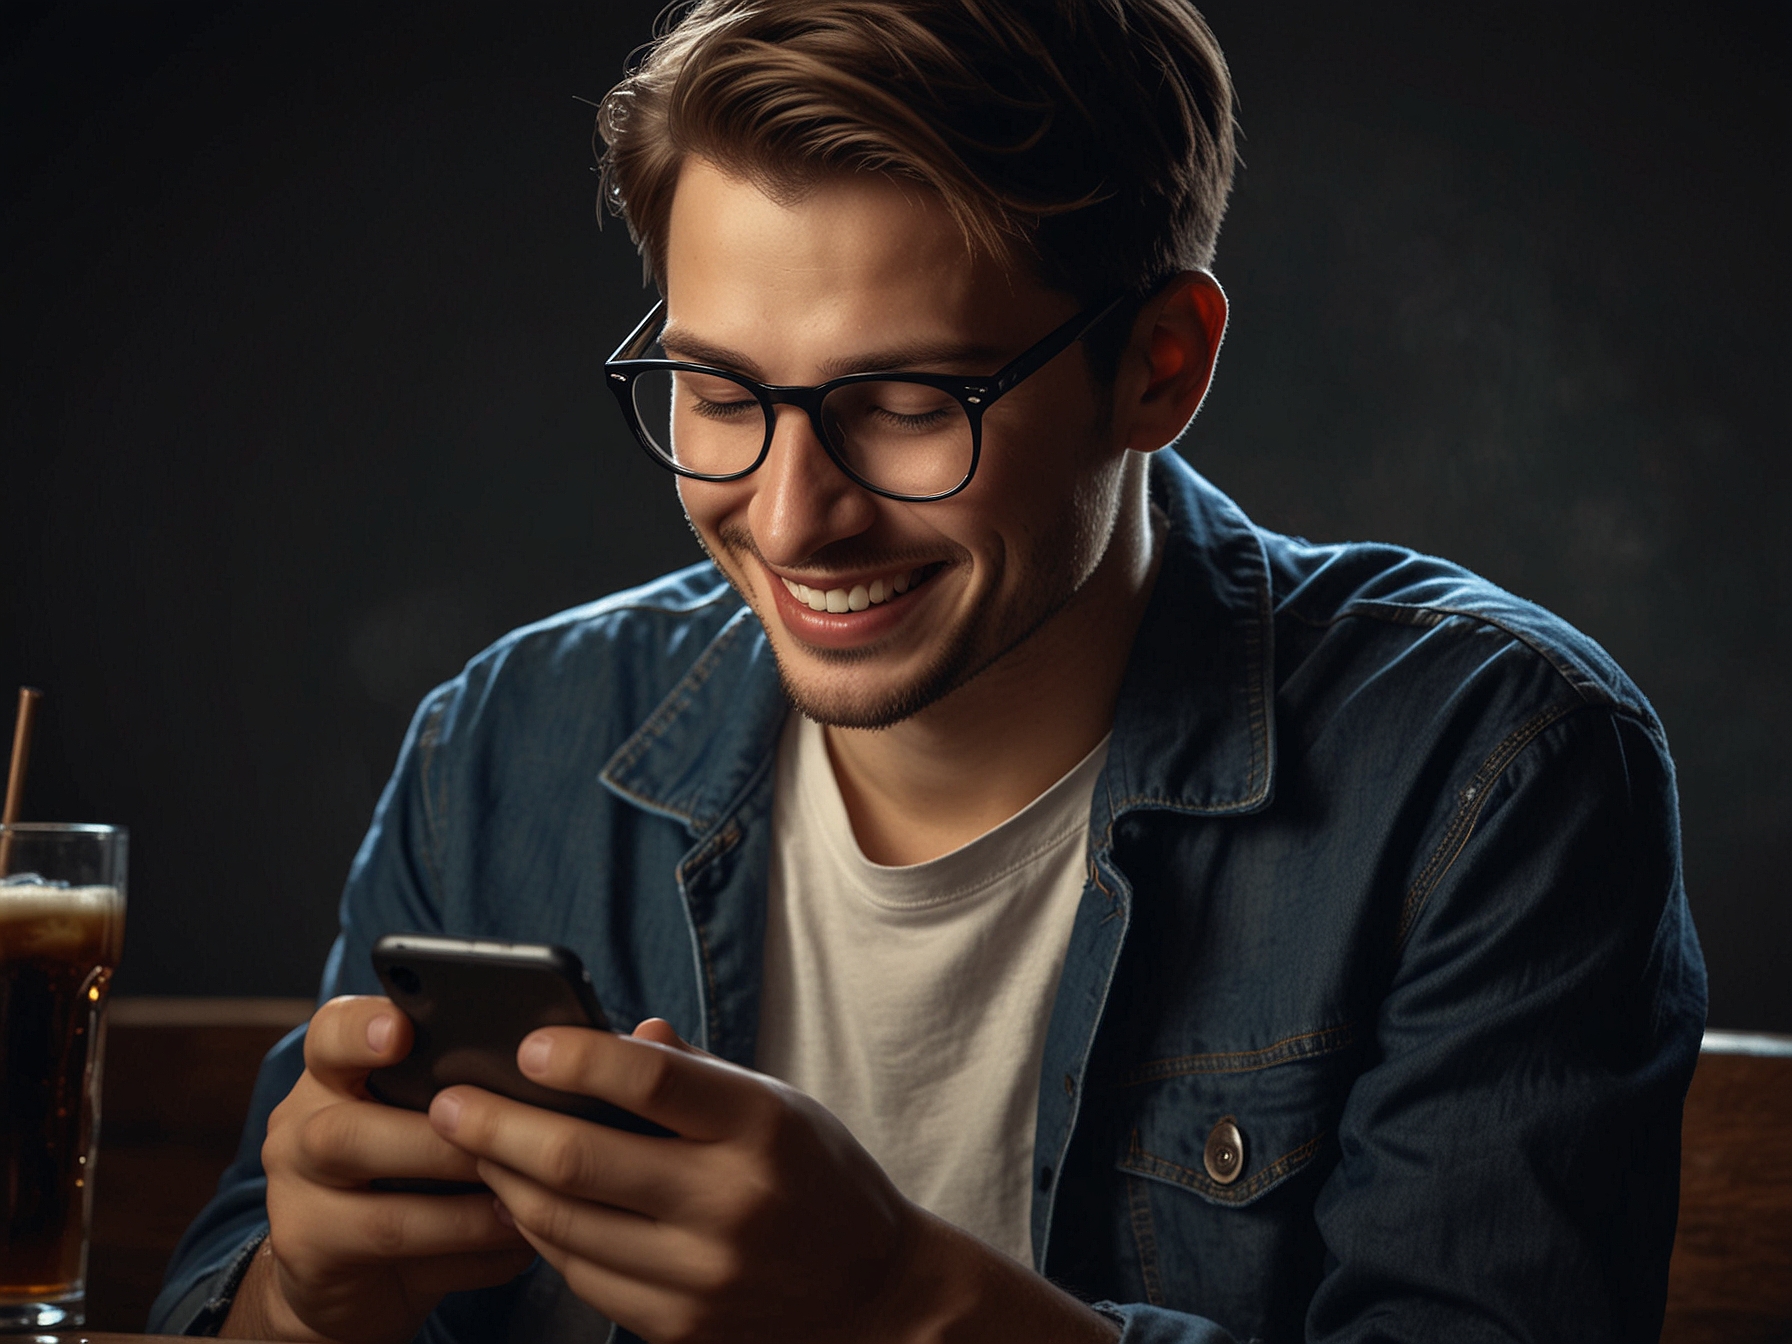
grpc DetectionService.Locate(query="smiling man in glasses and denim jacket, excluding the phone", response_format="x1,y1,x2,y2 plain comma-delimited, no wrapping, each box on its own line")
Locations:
156,0,1704,1342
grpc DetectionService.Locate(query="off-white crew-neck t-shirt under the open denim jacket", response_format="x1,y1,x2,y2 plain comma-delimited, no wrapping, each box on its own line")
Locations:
756,713,1107,1263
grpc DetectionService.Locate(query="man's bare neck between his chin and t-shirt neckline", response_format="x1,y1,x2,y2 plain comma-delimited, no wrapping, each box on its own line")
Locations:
826,459,1163,864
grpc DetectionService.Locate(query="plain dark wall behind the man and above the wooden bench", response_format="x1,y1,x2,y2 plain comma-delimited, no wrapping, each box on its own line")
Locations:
0,0,1792,1030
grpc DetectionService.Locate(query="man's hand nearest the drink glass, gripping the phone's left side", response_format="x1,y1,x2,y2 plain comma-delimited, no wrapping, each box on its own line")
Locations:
222,998,534,1344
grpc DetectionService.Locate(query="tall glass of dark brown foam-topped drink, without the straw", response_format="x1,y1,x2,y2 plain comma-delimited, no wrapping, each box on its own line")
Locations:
0,824,125,1330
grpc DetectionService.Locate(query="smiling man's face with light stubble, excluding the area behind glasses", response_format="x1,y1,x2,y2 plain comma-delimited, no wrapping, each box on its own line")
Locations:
665,159,1124,728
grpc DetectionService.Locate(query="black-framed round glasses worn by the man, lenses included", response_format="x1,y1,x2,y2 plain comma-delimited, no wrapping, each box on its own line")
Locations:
604,292,1125,504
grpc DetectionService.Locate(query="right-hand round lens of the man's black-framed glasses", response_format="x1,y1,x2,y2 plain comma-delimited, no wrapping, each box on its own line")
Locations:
821,380,971,495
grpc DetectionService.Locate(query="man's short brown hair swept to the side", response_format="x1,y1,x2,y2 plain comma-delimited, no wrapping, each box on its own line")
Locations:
597,0,1233,315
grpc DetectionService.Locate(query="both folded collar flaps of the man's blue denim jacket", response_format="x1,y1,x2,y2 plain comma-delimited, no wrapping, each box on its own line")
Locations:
602,452,1274,837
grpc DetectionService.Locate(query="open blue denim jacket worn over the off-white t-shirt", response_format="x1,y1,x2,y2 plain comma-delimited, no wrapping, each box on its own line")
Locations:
151,453,1704,1344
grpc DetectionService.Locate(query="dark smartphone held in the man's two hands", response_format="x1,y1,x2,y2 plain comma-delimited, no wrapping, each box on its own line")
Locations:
367,934,672,1134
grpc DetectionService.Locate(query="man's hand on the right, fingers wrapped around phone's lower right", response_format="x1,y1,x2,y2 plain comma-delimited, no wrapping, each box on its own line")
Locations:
430,1020,1116,1344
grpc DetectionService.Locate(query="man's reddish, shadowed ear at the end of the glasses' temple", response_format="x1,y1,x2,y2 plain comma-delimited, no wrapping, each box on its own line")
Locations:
1115,271,1226,453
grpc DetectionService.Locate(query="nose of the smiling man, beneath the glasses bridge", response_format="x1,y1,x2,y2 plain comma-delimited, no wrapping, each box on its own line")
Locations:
747,405,876,566
